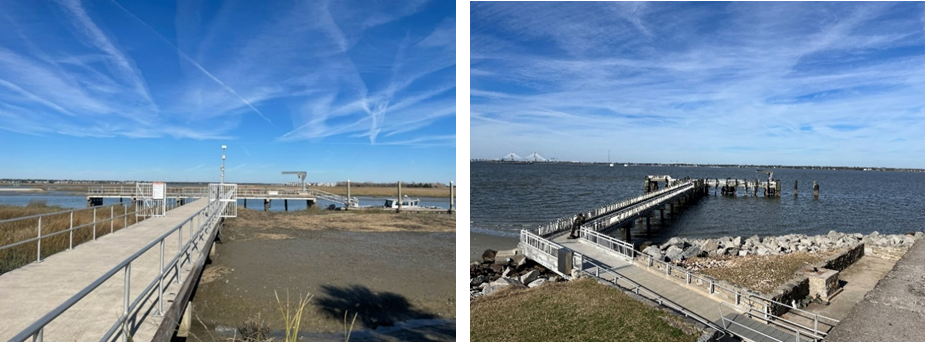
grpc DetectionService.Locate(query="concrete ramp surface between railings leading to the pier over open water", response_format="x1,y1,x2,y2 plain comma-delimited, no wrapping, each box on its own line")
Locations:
554,236,720,322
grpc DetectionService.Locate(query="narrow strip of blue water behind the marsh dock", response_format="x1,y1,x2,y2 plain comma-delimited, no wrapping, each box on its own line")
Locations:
0,191,465,211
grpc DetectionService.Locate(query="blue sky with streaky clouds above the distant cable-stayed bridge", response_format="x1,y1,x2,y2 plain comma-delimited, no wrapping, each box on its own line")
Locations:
469,2,925,168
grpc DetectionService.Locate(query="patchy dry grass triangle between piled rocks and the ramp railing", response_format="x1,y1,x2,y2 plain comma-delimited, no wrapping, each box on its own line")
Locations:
688,252,835,293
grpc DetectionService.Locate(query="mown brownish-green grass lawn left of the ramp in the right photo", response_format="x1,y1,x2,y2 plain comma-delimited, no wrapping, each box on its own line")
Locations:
469,279,700,342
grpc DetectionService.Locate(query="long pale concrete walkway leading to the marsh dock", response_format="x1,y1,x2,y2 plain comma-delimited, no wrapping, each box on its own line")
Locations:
0,200,208,341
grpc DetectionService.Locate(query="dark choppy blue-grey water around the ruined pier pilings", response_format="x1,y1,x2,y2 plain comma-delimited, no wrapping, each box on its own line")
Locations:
469,163,925,238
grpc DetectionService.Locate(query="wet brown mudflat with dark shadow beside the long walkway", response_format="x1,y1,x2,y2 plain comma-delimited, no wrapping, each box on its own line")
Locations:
193,209,456,340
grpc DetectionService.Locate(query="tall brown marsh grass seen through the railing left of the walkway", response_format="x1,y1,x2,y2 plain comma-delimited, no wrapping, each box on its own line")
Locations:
0,202,152,274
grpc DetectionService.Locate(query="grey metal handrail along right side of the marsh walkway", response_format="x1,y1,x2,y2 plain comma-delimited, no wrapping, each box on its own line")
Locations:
11,195,224,341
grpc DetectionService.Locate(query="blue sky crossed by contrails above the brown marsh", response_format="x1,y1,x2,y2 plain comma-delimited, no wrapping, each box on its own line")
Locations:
0,0,456,183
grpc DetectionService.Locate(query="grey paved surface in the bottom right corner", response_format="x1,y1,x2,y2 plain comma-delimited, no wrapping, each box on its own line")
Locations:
826,239,925,342
